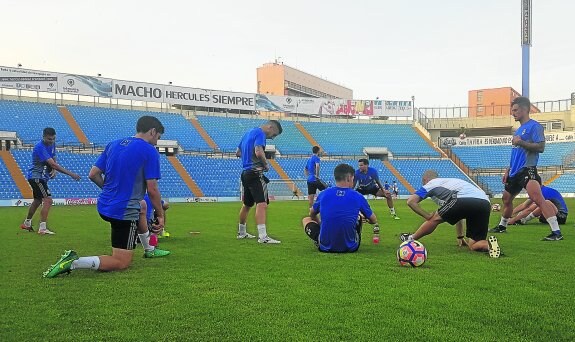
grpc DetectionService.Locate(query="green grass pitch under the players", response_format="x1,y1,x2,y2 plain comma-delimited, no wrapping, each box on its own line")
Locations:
0,200,575,341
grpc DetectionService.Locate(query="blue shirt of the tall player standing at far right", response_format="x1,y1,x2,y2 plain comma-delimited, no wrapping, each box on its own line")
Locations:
509,119,545,177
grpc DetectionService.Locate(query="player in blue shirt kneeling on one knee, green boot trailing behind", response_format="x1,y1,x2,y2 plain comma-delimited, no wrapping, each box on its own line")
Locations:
44,116,170,278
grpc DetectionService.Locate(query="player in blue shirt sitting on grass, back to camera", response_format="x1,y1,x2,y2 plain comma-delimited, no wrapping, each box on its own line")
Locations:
302,164,377,253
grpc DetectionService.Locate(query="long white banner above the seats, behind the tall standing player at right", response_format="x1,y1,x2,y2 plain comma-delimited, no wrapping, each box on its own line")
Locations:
439,132,575,148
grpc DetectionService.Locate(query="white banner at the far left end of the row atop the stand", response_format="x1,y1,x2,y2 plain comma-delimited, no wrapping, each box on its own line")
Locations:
0,67,58,93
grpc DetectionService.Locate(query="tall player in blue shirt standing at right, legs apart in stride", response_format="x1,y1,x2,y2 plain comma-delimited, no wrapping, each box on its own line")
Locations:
491,97,563,241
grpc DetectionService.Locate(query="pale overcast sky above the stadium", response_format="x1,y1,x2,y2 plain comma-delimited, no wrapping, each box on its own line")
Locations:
0,0,575,107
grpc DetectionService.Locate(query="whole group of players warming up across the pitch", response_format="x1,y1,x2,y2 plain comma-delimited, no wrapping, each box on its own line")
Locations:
27,97,567,278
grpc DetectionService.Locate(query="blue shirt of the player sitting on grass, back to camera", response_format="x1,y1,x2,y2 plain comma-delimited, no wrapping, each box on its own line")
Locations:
313,186,373,252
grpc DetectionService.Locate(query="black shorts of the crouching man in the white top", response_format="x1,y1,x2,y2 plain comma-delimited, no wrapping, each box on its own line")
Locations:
437,196,491,241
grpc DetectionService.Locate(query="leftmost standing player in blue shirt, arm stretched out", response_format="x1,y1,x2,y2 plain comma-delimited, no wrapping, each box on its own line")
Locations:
20,127,80,235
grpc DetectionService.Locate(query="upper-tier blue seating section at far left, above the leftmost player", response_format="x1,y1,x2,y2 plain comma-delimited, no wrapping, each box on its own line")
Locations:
0,100,78,144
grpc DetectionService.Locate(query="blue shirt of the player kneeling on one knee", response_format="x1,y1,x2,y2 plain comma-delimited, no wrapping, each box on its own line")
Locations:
94,137,161,220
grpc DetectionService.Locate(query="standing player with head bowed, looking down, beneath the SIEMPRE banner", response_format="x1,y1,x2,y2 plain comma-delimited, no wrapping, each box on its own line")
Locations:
236,120,282,243
